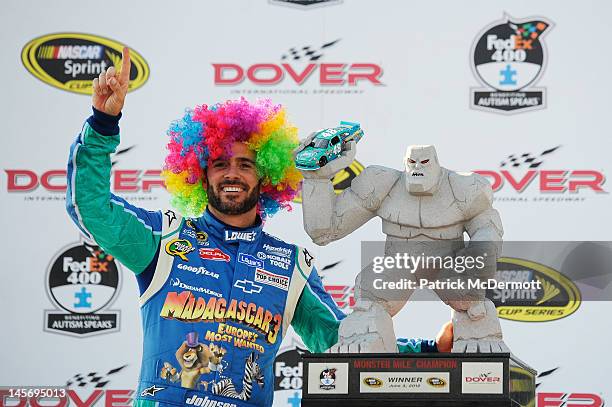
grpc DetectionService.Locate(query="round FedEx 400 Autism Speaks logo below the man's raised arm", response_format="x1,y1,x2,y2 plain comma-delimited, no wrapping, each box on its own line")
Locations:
44,242,121,337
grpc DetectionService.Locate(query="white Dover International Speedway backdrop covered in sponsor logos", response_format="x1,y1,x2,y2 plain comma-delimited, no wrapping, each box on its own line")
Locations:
0,0,612,406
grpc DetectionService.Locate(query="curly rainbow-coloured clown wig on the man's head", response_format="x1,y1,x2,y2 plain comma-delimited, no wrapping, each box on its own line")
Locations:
162,98,302,219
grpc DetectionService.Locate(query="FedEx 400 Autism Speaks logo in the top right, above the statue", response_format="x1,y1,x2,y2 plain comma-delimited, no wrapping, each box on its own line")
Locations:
470,15,553,114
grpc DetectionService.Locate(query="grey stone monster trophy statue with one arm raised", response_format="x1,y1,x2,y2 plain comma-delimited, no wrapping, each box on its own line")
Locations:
297,126,509,353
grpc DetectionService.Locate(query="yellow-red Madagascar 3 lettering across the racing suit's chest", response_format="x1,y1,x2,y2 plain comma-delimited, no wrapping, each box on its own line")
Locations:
160,291,282,343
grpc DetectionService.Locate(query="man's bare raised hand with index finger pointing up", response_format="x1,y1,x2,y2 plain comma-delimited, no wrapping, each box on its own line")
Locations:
92,47,132,116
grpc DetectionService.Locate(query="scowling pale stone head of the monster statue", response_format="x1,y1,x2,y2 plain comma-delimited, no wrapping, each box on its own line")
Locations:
404,145,442,195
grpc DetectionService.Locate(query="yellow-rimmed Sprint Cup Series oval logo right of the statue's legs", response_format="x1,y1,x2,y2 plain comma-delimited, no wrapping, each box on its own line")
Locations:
487,257,582,322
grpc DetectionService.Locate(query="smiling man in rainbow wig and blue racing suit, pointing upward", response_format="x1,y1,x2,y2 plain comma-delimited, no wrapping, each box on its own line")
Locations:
66,48,452,407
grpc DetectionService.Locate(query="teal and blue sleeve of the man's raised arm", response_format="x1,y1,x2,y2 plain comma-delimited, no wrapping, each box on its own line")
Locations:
66,110,162,274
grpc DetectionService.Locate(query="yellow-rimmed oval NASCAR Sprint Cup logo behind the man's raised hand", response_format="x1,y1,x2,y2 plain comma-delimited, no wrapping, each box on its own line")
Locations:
21,33,149,95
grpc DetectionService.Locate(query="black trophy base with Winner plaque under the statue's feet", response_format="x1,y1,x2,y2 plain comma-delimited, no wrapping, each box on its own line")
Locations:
302,353,536,407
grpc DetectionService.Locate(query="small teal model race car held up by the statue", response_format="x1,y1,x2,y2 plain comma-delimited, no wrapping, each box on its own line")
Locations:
295,122,363,170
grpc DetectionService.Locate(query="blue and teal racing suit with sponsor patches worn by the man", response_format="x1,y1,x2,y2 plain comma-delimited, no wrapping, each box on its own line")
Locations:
66,110,436,407
